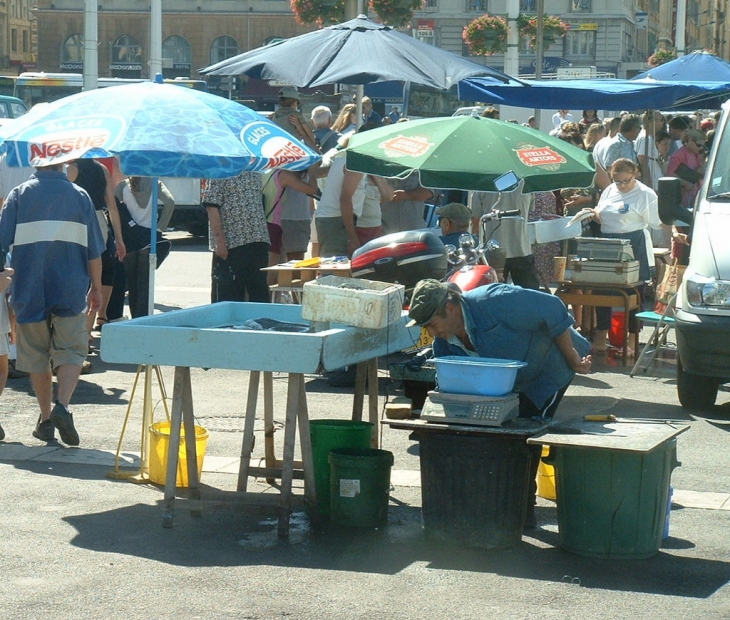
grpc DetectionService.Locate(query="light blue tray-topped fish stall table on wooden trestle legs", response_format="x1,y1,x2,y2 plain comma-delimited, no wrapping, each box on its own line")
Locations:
101,302,418,536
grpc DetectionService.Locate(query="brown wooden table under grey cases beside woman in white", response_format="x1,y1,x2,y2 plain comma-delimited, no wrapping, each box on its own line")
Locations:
555,280,641,366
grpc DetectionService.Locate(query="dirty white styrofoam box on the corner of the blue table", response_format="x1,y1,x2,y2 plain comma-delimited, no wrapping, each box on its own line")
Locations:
302,276,405,329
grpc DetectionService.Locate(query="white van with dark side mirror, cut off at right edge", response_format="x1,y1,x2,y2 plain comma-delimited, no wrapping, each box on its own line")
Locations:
659,102,730,409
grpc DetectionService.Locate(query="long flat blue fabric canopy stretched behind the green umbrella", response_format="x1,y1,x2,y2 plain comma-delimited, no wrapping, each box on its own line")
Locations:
458,77,730,110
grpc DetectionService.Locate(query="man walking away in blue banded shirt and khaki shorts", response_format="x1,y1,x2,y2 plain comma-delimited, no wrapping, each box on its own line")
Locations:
0,164,104,446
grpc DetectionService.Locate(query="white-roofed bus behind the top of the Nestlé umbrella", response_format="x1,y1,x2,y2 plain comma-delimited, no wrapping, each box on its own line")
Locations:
12,72,208,108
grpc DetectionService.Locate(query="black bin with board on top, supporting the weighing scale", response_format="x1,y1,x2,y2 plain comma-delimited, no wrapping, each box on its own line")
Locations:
383,416,547,549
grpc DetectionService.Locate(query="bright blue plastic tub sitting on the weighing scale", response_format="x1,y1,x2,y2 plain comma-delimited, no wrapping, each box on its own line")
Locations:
433,355,527,396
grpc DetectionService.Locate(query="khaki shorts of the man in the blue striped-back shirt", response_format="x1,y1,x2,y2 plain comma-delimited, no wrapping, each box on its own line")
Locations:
16,313,89,374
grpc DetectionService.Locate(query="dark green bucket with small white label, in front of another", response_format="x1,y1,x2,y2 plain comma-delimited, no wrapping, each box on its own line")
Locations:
329,448,393,527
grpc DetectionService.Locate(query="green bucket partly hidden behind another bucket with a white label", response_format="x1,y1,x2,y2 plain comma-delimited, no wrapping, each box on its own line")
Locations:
309,420,373,515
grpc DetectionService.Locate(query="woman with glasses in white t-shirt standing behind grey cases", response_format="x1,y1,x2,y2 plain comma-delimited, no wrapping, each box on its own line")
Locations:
593,158,662,354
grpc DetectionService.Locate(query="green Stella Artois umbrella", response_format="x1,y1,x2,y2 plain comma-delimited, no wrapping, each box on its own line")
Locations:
346,116,595,193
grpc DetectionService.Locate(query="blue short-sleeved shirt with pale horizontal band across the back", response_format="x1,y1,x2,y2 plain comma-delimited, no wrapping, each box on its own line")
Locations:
0,169,104,323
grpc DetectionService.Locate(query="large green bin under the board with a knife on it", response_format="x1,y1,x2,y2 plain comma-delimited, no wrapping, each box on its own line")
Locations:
548,439,680,560
